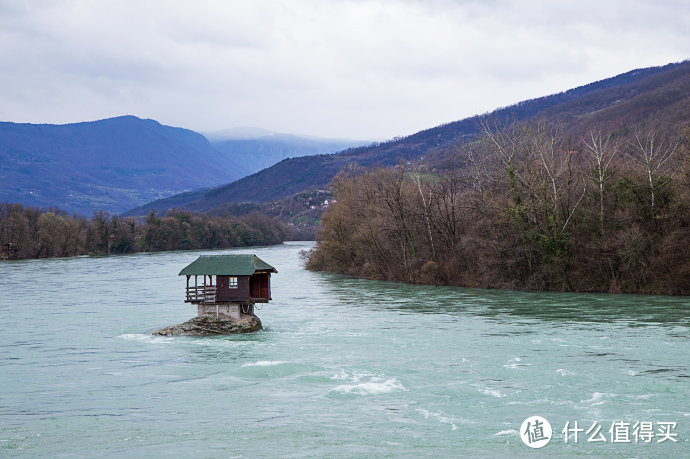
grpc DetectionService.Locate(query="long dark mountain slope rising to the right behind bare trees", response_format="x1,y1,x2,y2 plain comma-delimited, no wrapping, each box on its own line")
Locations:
128,61,690,215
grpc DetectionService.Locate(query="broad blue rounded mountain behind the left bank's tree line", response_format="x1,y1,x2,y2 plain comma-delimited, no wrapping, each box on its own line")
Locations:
0,116,249,215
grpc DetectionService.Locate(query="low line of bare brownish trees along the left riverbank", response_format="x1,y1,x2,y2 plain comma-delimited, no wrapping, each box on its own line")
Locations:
0,207,286,259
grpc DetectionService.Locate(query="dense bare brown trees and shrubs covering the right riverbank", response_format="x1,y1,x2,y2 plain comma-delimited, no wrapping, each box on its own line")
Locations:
304,118,690,295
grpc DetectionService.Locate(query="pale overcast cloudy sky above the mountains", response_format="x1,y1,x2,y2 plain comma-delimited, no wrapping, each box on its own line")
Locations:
0,0,690,139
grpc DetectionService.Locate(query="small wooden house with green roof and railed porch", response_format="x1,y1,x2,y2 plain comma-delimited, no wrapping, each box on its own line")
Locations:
179,254,278,319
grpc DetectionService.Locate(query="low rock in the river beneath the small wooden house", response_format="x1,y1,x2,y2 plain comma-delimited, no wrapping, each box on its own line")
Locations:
152,314,262,336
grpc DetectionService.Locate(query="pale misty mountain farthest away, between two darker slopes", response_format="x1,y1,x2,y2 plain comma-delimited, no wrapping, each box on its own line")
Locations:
206,128,366,173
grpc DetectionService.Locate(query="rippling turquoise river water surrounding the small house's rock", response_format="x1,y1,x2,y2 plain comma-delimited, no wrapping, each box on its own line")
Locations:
0,243,690,457
